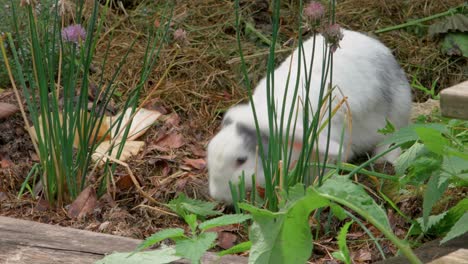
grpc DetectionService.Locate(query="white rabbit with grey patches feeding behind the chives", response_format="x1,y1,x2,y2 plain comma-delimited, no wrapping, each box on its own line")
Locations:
207,30,411,202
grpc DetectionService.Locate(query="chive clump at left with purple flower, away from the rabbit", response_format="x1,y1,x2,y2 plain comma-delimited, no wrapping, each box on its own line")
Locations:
0,0,172,206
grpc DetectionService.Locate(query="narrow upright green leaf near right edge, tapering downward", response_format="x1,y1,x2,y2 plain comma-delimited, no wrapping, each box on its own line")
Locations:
422,174,449,228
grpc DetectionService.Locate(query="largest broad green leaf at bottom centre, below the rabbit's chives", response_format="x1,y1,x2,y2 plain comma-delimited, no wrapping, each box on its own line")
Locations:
240,189,329,264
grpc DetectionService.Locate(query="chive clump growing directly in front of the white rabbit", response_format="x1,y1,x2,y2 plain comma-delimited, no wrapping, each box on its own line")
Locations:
231,0,342,210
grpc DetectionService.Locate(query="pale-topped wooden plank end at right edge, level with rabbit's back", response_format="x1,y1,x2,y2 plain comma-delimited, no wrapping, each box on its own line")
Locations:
440,81,468,120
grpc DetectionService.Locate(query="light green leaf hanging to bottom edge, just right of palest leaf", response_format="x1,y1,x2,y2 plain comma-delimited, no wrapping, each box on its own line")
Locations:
176,232,218,263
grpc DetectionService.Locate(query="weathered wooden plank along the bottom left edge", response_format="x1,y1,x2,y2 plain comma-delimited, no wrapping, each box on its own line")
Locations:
0,216,247,264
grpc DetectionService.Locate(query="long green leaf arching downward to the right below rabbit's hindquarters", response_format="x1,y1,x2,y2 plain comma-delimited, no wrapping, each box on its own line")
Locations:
318,175,391,230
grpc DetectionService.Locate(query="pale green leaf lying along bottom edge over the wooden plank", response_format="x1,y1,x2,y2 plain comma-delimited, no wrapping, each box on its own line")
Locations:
95,247,181,264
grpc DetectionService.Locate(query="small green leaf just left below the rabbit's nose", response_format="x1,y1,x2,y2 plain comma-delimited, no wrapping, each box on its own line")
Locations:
167,193,221,217
